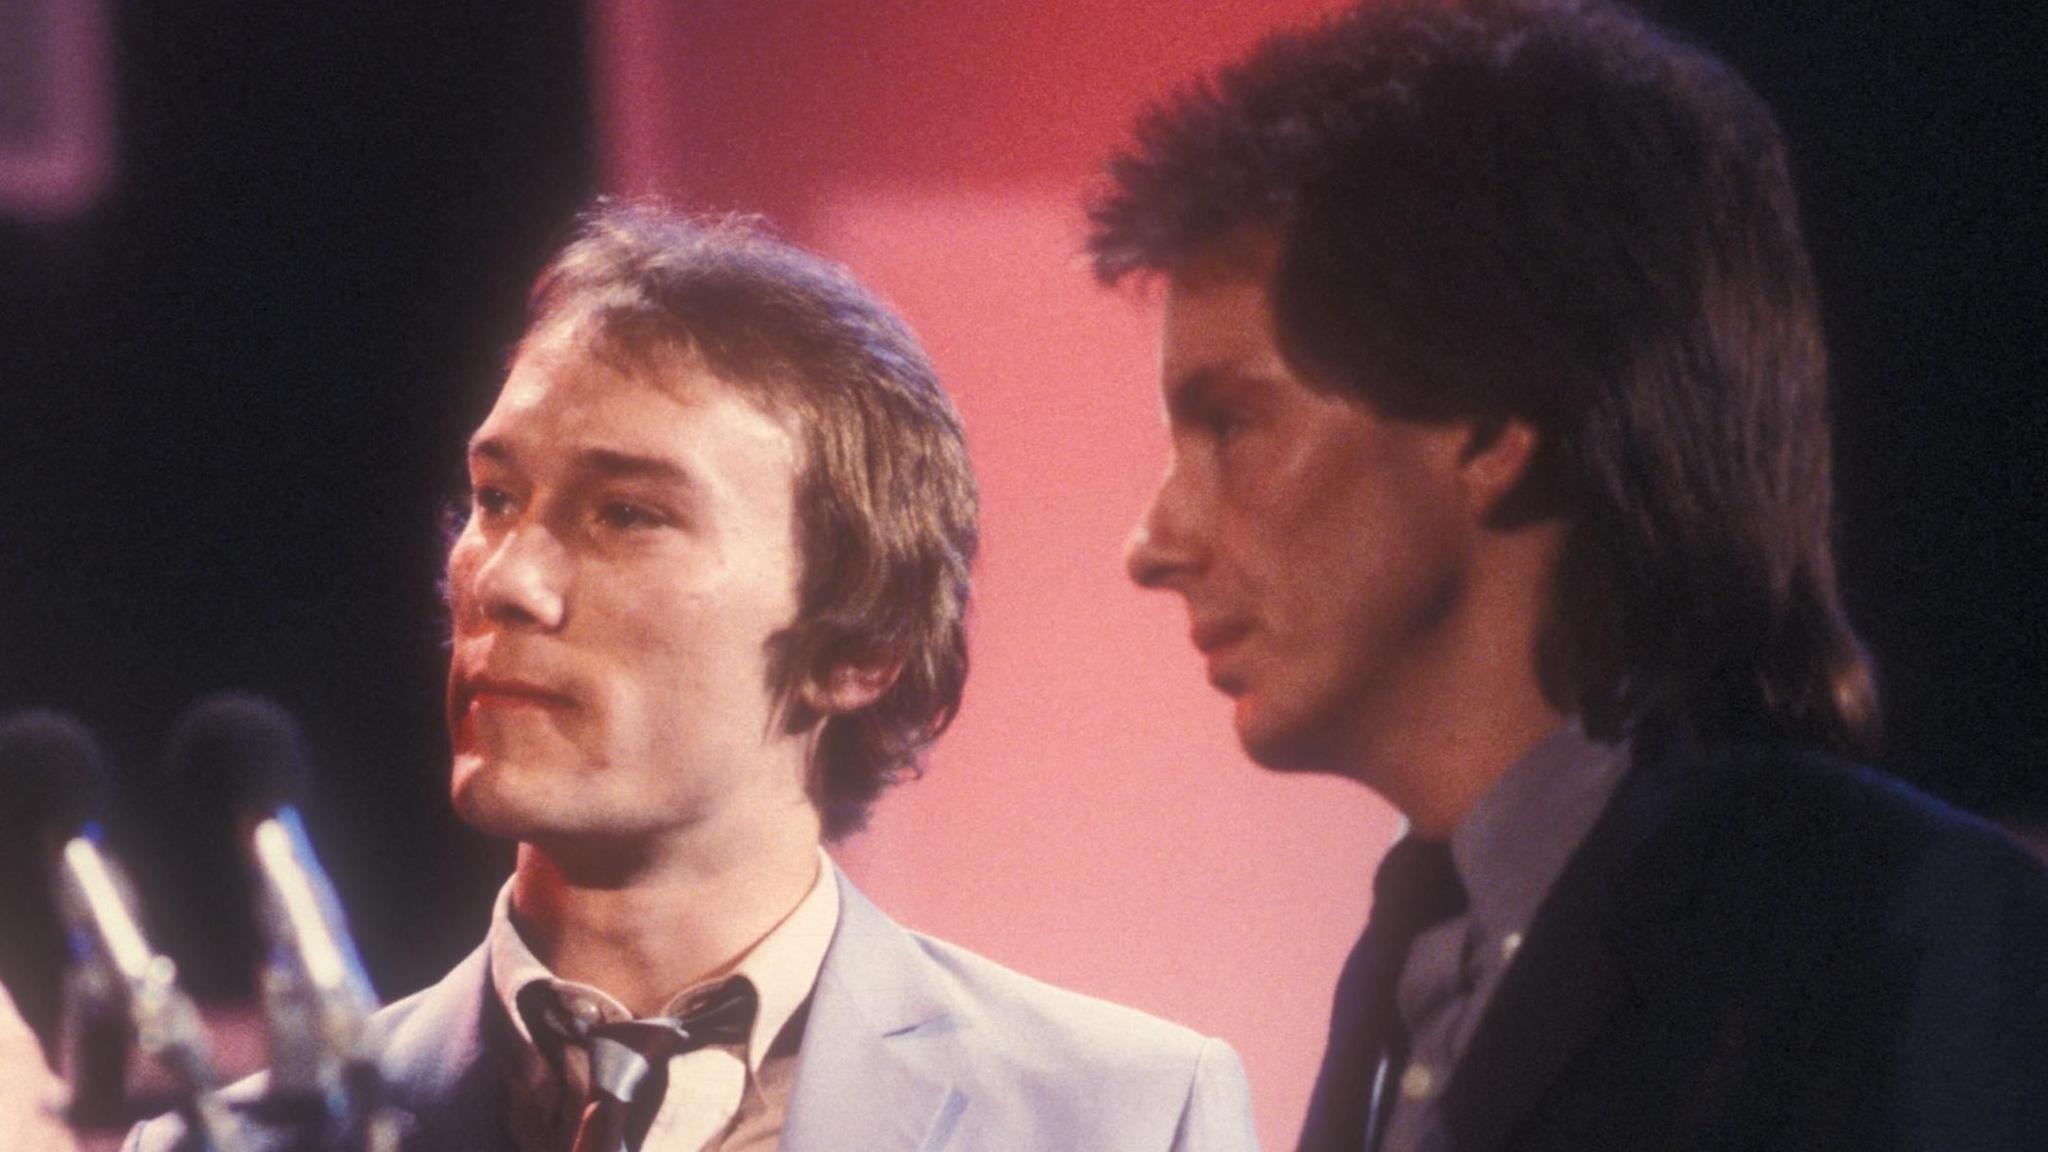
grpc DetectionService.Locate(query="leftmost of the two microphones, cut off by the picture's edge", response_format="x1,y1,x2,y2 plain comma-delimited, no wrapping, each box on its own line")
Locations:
0,711,229,1152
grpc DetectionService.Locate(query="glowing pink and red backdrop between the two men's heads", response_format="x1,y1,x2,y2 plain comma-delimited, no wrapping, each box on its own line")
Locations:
596,0,1395,1148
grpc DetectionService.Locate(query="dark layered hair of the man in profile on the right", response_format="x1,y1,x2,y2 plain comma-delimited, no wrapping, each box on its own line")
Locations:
1090,0,1878,754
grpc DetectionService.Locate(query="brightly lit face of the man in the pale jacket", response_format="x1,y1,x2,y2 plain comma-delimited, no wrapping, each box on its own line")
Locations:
449,324,807,842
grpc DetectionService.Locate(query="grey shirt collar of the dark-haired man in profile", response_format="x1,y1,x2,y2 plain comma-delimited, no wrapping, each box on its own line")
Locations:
1450,717,1628,951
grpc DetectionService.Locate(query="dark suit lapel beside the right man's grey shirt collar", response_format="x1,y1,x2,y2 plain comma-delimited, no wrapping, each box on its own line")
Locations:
1444,717,1716,1152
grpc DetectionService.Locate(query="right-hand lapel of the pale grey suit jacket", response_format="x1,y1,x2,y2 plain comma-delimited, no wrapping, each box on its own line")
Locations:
782,869,967,1152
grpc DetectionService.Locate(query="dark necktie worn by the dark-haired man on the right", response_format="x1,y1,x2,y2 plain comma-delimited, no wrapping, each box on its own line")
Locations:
1300,836,1466,1152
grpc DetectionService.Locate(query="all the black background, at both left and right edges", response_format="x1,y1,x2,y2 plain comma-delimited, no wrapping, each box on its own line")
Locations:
0,0,2048,1057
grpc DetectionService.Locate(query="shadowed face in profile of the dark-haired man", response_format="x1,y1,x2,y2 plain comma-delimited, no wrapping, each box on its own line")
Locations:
1126,240,1468,775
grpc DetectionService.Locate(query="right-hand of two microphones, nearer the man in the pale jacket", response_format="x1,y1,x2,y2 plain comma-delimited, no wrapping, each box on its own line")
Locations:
170,693,397,1150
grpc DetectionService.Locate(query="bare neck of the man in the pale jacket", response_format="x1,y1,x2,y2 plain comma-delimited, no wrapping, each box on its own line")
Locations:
512,806,819,1017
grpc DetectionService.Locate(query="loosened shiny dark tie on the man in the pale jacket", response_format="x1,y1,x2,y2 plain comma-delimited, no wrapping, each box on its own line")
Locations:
535,976,758,1152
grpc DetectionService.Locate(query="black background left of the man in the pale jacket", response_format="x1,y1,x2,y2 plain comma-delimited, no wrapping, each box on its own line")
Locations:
0,0,594,1035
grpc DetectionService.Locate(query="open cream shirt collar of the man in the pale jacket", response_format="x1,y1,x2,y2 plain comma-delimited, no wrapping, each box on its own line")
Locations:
487,849,840,1074
